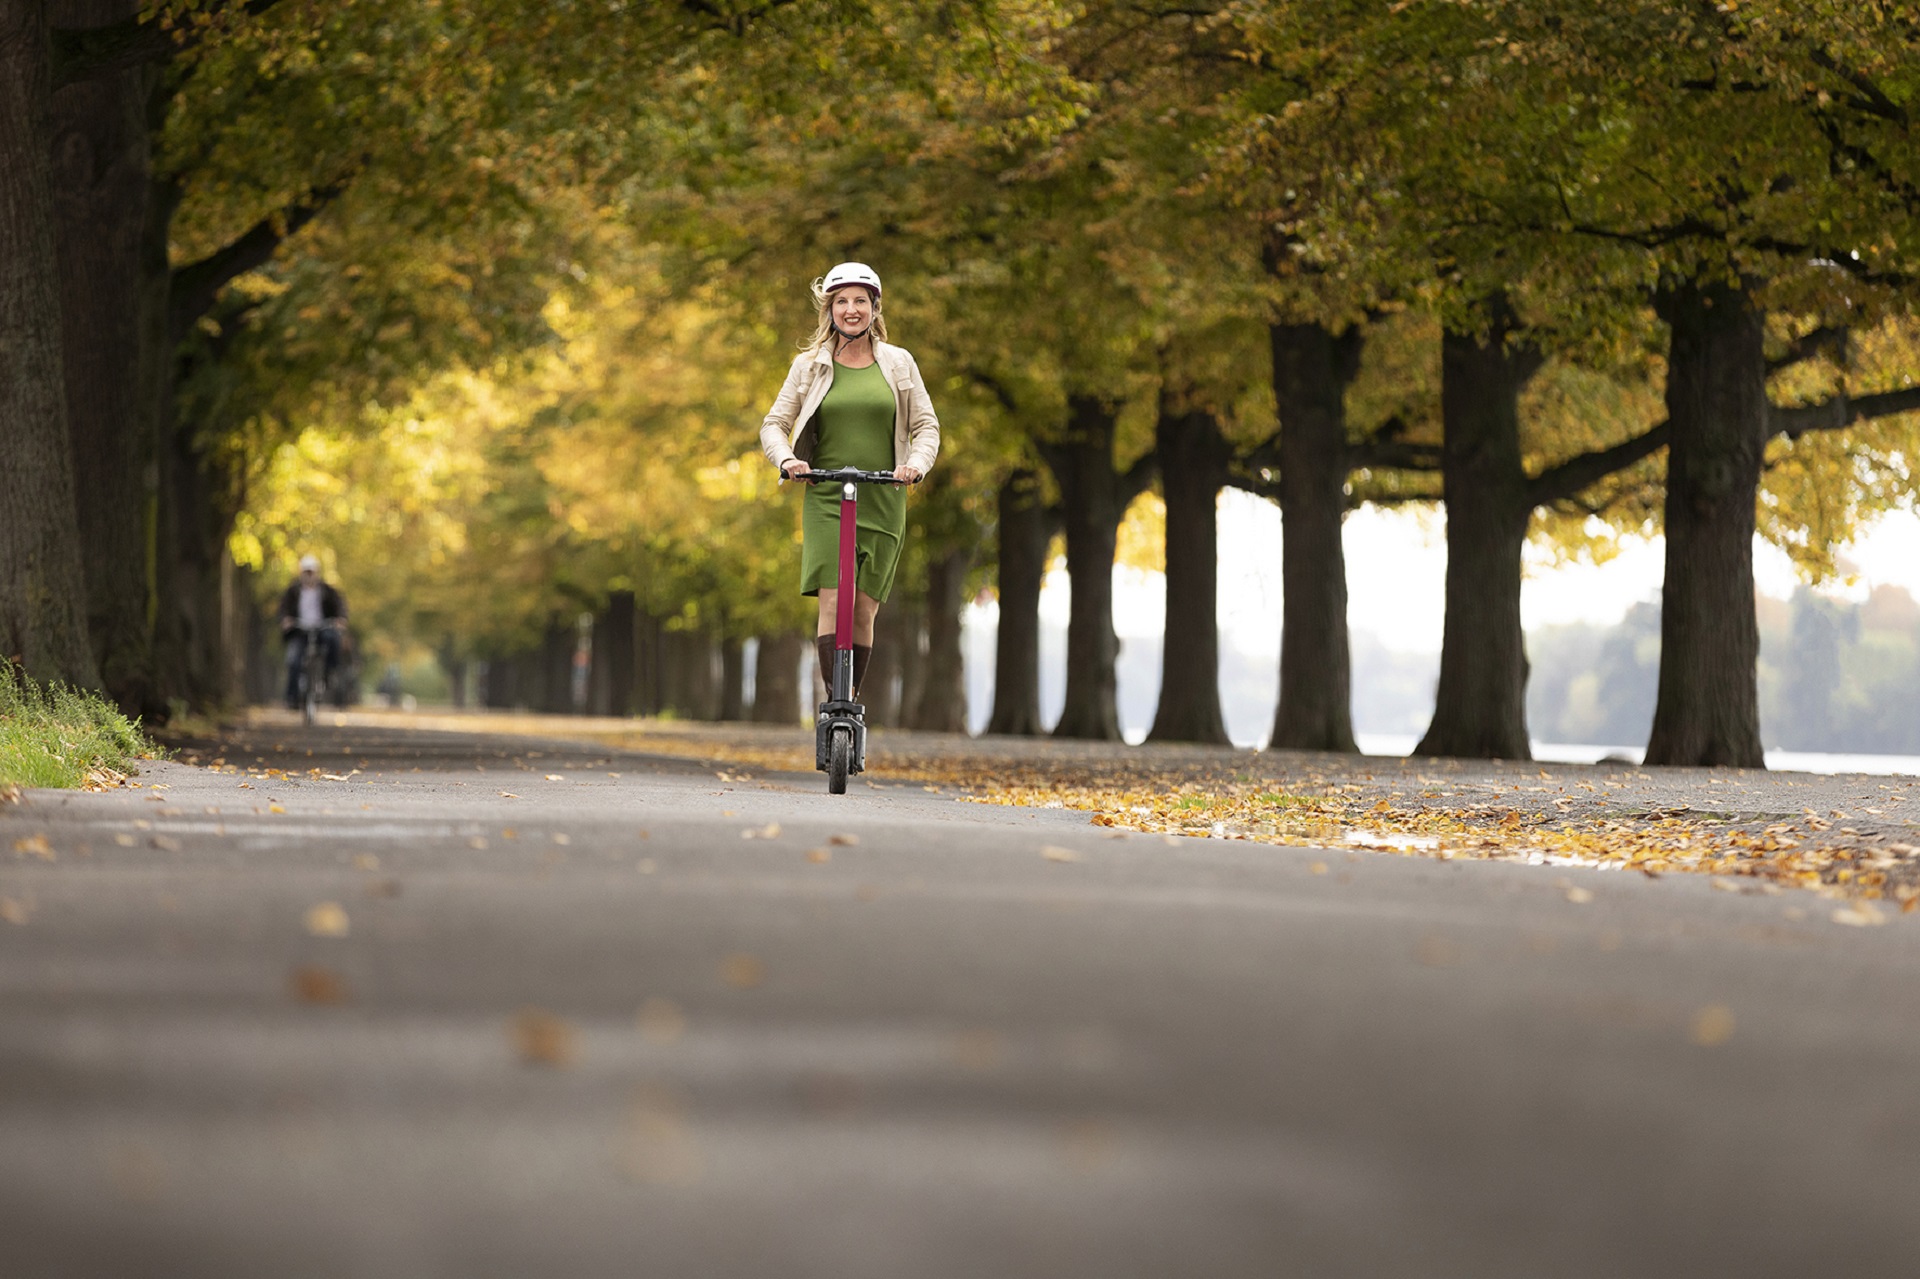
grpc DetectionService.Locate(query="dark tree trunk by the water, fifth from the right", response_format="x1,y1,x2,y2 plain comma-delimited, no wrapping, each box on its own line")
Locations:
1041,396,1123,741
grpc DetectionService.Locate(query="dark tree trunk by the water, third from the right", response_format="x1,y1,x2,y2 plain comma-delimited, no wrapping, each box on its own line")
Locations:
1267,325,1361,753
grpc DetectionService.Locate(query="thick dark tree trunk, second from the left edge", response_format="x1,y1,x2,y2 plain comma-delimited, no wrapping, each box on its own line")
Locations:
50,0,154,722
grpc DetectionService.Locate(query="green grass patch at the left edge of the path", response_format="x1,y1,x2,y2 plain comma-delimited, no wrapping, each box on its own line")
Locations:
0,661,152,787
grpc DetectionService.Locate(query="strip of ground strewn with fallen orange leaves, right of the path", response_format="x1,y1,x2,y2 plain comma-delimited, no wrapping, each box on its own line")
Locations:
602,732,1920,910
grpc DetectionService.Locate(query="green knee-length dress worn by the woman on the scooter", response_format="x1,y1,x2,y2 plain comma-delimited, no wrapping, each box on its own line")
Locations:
801,363,906,603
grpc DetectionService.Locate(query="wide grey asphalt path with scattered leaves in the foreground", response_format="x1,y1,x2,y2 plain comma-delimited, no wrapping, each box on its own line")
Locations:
0,726,1920,1279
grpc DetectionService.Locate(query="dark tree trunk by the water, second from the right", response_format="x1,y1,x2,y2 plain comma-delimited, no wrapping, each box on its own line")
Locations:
1413,311,1540,759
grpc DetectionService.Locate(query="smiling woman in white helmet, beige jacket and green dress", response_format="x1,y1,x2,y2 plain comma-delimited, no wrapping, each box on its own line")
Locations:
760,261,941,695
